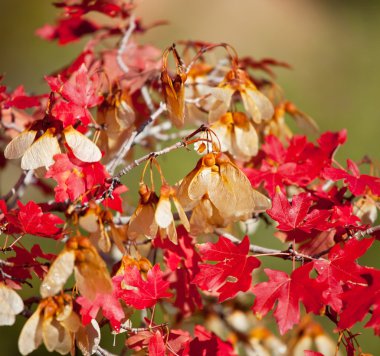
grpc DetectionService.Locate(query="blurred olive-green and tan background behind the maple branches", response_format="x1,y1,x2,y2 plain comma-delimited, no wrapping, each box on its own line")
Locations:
0,0,380,355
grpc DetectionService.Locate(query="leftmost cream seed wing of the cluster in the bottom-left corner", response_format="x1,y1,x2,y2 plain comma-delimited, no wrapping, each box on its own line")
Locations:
18,307,42,355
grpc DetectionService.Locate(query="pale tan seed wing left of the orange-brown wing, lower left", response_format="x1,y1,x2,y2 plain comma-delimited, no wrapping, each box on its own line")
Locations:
40,251,75,298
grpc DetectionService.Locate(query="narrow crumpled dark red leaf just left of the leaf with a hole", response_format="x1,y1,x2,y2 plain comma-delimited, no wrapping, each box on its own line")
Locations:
154,225,202,316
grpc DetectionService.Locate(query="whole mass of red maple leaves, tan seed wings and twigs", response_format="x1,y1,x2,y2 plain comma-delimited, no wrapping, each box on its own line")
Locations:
0,0,380,355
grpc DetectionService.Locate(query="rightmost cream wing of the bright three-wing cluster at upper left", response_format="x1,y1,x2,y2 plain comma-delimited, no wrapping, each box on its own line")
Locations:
63,126,102,162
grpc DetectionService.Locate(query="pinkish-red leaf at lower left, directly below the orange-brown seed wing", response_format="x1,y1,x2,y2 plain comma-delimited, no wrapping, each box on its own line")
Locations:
76,278,125,331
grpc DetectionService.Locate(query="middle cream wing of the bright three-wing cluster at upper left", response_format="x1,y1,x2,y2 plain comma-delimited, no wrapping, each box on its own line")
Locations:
21,129,61,170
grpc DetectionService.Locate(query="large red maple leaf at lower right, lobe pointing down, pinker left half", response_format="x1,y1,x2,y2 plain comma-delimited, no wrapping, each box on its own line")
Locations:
252,263,323,335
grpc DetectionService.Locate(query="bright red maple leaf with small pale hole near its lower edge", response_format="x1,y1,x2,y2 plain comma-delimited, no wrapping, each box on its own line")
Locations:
193,236,260,302
